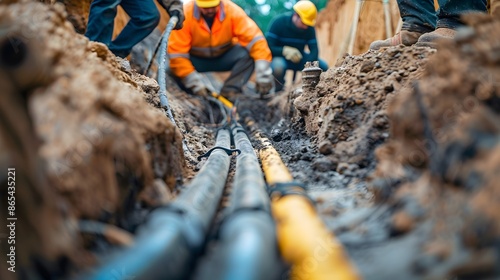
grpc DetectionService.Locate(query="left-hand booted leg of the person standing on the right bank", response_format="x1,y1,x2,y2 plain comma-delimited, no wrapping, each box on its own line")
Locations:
370,0,437,50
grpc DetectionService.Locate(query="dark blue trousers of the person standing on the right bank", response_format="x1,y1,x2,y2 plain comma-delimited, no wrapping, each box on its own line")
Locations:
398,0,487,33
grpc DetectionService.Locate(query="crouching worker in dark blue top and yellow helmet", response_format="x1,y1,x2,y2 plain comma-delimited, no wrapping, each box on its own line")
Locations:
266,0,328,91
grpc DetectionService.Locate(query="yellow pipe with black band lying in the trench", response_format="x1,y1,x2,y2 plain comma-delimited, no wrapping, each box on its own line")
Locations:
254,127,360,280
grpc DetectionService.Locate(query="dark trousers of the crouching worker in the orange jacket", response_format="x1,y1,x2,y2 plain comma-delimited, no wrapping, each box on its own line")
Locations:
191,45,254,94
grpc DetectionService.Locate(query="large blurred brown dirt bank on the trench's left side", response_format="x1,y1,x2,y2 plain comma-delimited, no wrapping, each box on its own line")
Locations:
0,1,184,273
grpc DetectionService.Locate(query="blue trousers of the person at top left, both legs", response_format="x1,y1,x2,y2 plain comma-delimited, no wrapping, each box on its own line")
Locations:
85,0,160,57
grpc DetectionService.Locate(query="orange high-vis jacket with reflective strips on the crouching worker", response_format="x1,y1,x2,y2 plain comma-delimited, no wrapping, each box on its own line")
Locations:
168,0,271,78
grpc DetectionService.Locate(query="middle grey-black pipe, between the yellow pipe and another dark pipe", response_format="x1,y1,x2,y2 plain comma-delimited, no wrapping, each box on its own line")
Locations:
196,126,283,280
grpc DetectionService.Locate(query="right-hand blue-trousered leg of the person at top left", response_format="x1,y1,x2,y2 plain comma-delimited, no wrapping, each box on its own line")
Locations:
109,0,160,57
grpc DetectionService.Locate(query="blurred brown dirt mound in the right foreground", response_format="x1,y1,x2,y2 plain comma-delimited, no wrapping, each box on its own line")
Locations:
372,15,500,279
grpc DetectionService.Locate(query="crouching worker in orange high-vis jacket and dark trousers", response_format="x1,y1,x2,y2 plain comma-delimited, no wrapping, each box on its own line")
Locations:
168,0,274,98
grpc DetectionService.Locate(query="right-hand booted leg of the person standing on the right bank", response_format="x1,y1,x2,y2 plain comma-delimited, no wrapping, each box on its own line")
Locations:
417,0,487,48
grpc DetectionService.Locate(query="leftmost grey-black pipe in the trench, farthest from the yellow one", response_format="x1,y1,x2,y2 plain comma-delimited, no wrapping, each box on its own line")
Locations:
82,129,230,280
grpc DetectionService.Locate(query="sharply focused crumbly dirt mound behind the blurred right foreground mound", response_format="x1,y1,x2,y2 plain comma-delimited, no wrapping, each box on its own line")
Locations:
294,47,434,173
